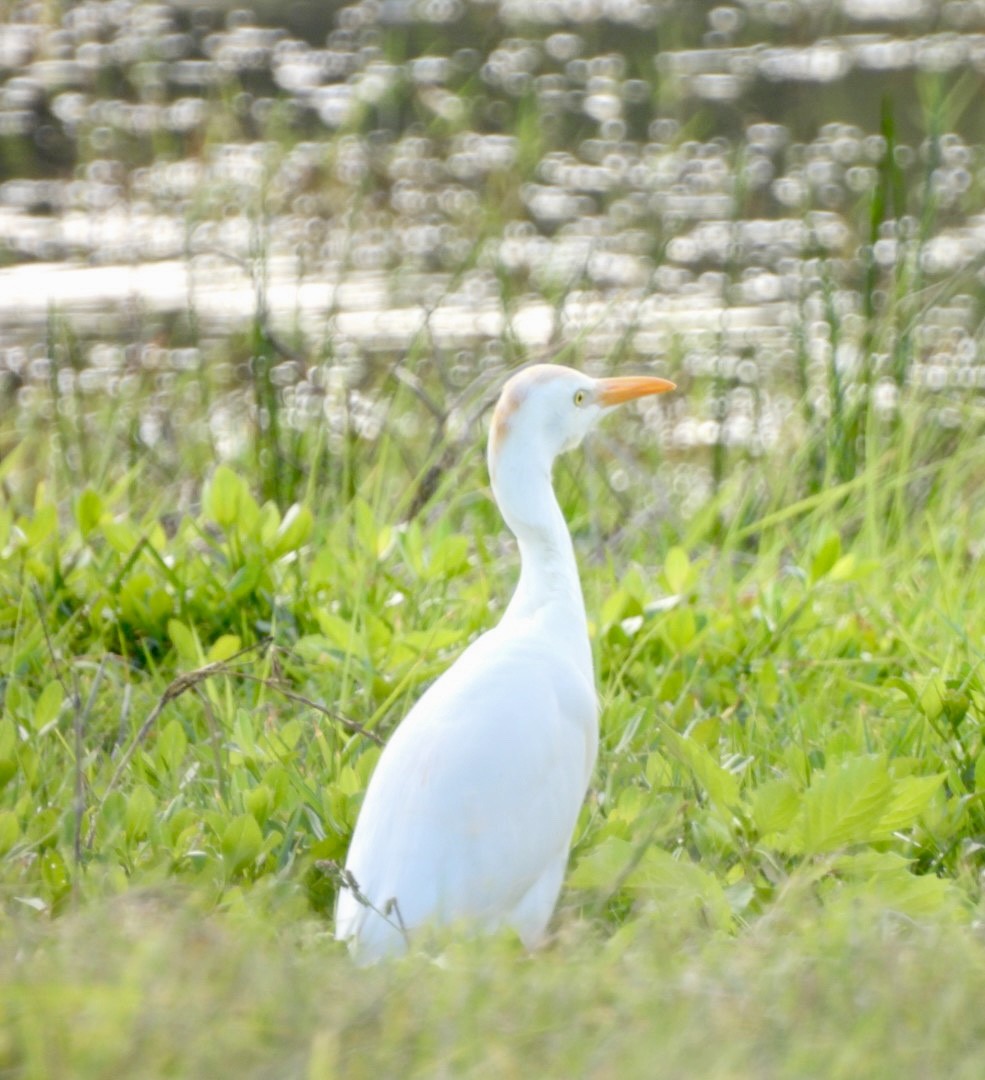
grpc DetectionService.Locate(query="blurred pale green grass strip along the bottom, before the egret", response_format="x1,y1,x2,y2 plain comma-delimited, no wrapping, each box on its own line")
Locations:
0,894,985,1078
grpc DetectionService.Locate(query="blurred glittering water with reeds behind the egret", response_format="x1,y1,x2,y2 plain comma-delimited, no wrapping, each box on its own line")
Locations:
0,0,985,517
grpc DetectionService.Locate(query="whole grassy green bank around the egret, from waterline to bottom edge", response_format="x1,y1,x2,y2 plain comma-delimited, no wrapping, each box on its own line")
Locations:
0,334,985,1077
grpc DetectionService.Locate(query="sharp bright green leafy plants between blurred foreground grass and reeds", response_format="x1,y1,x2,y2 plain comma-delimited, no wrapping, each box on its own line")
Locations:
0,416,985,933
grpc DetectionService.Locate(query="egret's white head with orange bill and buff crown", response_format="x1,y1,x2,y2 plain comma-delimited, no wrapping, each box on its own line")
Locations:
489,364,674,480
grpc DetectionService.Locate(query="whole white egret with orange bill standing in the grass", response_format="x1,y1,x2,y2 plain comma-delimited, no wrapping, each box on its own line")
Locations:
336,364,674,962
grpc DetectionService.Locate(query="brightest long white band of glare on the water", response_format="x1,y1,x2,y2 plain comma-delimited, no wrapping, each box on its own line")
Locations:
0,251,795,352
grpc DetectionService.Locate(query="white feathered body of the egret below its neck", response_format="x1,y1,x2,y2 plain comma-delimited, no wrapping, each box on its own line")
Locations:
336,627,598,959
